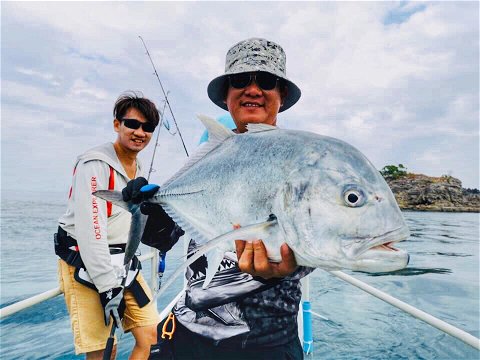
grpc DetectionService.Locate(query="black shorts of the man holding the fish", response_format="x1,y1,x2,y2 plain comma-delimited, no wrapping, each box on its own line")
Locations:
149,321,303,360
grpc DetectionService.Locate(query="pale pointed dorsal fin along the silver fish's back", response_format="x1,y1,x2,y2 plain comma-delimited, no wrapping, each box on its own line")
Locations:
162,115,236,188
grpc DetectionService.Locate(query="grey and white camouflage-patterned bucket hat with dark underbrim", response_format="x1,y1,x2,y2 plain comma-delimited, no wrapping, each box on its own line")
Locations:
207,38,301,112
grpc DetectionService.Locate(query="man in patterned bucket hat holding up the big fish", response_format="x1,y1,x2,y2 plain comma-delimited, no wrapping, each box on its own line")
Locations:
142,38,313,360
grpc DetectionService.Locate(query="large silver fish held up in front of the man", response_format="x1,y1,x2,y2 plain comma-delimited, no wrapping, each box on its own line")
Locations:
96,116,409,287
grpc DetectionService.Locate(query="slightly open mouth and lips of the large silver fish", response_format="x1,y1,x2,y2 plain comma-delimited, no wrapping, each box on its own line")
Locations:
342,226,410,259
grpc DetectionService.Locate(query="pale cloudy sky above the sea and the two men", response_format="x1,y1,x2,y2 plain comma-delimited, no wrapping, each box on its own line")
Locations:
1,1,480,198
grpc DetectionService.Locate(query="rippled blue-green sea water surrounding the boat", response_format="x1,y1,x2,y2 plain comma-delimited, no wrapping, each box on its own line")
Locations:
0,192,480,359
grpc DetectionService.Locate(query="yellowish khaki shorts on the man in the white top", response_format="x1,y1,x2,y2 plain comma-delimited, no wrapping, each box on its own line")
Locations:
58,260,160,355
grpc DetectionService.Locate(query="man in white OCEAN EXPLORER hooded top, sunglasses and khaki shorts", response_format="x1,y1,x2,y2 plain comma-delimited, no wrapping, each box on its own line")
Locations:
55,93,169,359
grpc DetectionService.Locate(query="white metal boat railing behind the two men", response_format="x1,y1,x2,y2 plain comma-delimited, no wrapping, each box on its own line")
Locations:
0,251,480,354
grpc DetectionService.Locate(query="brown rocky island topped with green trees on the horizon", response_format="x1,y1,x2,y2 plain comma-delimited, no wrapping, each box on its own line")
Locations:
380,164,480,212
